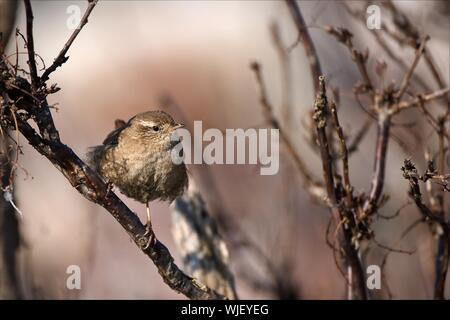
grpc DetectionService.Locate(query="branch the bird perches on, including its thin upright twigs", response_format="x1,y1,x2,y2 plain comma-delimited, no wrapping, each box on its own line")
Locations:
0,1,225,299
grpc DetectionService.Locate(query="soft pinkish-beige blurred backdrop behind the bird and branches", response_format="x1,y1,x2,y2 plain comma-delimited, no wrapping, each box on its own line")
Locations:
0,0,450,299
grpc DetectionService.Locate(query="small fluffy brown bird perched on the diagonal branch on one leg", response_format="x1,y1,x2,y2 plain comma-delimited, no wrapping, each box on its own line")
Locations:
87,111,188,242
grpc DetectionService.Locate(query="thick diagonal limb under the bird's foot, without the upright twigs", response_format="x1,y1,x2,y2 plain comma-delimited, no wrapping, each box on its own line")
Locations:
0,99,223,299
